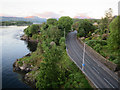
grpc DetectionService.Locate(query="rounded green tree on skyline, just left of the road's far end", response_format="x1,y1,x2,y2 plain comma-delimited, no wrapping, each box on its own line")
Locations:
58,16,73,34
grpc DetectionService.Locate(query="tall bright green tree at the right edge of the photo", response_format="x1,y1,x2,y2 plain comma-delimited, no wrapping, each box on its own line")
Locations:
107,16,120,53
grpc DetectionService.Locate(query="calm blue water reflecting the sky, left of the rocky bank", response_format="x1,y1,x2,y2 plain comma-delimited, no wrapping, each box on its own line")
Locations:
0,26,35,88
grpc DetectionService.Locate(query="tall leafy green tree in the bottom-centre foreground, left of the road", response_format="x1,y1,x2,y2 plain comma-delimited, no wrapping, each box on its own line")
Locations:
36,45,61,89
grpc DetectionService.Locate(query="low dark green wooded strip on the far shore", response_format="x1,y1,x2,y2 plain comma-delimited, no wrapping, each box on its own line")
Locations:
0,21,33,26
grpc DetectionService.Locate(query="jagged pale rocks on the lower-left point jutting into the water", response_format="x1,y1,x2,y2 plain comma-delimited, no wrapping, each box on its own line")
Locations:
13,53,39,88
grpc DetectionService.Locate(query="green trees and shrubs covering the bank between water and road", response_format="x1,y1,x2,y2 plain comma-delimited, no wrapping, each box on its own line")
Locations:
18,17,91,89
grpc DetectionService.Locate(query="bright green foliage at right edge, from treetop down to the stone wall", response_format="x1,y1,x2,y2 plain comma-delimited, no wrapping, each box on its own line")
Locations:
107,16,120,66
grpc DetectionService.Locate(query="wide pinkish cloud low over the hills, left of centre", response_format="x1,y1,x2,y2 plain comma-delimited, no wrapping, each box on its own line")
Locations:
36,12,61,18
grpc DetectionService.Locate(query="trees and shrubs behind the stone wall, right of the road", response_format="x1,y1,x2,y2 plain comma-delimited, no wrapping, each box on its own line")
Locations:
73,9,120,67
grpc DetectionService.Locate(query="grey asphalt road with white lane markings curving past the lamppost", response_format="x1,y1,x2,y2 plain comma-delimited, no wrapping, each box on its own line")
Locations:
66,31,120,89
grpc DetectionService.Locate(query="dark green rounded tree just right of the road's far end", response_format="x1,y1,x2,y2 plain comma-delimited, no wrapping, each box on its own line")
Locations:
78,19,96,37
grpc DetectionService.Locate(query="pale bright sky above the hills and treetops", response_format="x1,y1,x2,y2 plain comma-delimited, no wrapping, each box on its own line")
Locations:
0,0,120,19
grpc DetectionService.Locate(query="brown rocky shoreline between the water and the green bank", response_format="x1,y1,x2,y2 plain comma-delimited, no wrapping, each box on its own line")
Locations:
13,35,39,88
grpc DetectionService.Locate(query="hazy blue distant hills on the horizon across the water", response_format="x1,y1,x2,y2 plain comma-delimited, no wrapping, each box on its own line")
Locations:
0,16,46,23
